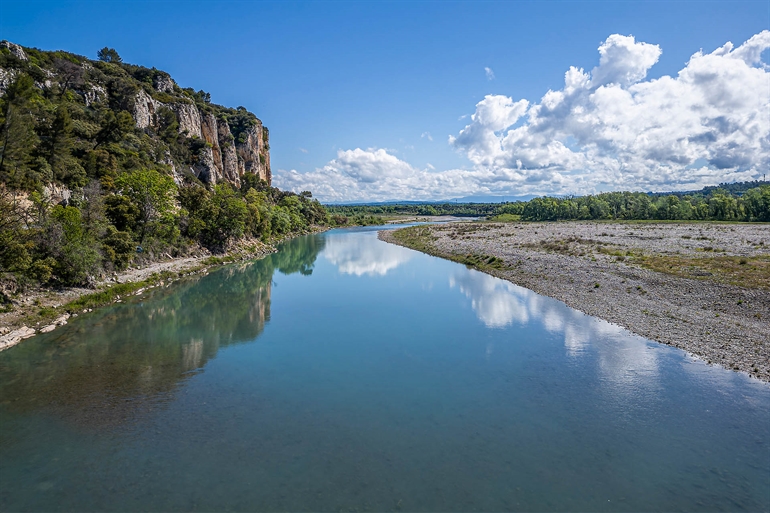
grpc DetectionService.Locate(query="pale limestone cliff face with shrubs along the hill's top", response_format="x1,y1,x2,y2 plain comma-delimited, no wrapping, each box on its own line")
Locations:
0,41,271,186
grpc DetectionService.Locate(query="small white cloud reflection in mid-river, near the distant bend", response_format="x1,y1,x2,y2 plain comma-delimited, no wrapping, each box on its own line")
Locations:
323,232,414,276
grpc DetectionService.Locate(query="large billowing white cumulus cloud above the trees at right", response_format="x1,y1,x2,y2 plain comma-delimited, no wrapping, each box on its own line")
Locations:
450,31,770,193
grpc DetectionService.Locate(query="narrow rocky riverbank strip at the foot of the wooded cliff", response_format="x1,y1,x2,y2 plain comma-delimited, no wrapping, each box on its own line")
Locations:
0,226,328,351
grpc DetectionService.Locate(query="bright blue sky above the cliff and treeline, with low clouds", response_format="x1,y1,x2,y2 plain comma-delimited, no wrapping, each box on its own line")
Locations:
0,0,770,201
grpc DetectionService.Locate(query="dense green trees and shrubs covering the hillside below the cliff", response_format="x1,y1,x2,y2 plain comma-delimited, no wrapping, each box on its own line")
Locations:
0,47,327,300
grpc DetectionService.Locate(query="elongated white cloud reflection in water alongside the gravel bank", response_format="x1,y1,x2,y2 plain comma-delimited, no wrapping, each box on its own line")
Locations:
449,266,658,386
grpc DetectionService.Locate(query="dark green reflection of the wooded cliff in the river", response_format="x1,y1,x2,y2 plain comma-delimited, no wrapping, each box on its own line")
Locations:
0,236,324,427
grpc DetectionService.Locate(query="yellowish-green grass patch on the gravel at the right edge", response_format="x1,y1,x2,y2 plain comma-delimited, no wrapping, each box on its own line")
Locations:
634,255,770,289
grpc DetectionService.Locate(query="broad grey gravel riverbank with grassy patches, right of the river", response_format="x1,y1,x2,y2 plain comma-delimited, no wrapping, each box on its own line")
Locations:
379,221,770,381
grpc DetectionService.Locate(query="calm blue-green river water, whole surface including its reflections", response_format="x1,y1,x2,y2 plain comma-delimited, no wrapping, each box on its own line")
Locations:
0,230,770,511
